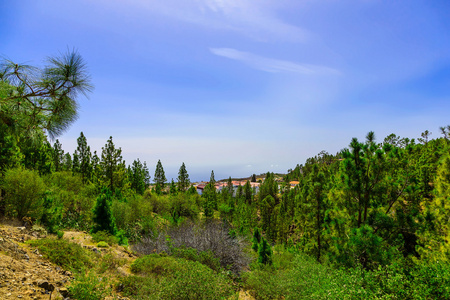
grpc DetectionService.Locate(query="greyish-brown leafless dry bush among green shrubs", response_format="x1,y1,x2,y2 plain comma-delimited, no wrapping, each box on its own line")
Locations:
133,221,250,275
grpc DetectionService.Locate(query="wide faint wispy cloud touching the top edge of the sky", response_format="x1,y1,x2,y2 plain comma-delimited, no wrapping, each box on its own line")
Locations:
123,0,310,42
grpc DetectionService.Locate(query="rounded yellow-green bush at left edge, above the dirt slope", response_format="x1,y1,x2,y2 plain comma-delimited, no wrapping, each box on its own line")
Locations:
1,168,45,220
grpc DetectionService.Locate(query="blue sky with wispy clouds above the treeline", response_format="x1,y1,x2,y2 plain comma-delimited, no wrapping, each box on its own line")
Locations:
0,0,450,180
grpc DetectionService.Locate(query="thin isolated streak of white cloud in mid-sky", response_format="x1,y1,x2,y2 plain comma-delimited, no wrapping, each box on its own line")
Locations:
209,48,340,75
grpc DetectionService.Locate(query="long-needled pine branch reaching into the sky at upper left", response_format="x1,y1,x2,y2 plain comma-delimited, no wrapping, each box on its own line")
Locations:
0,50,93,137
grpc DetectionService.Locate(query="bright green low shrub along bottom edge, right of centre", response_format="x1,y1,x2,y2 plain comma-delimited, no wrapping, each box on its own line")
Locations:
242,247,372,300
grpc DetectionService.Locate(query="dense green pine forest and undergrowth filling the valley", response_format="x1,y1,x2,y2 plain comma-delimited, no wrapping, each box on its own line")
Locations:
0,52,450,299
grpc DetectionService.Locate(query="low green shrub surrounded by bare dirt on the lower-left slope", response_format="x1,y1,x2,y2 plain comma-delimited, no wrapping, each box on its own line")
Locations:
27,239,94,272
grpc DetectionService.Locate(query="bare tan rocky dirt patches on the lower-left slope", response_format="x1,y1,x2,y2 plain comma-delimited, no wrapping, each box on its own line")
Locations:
0,221,254,300
